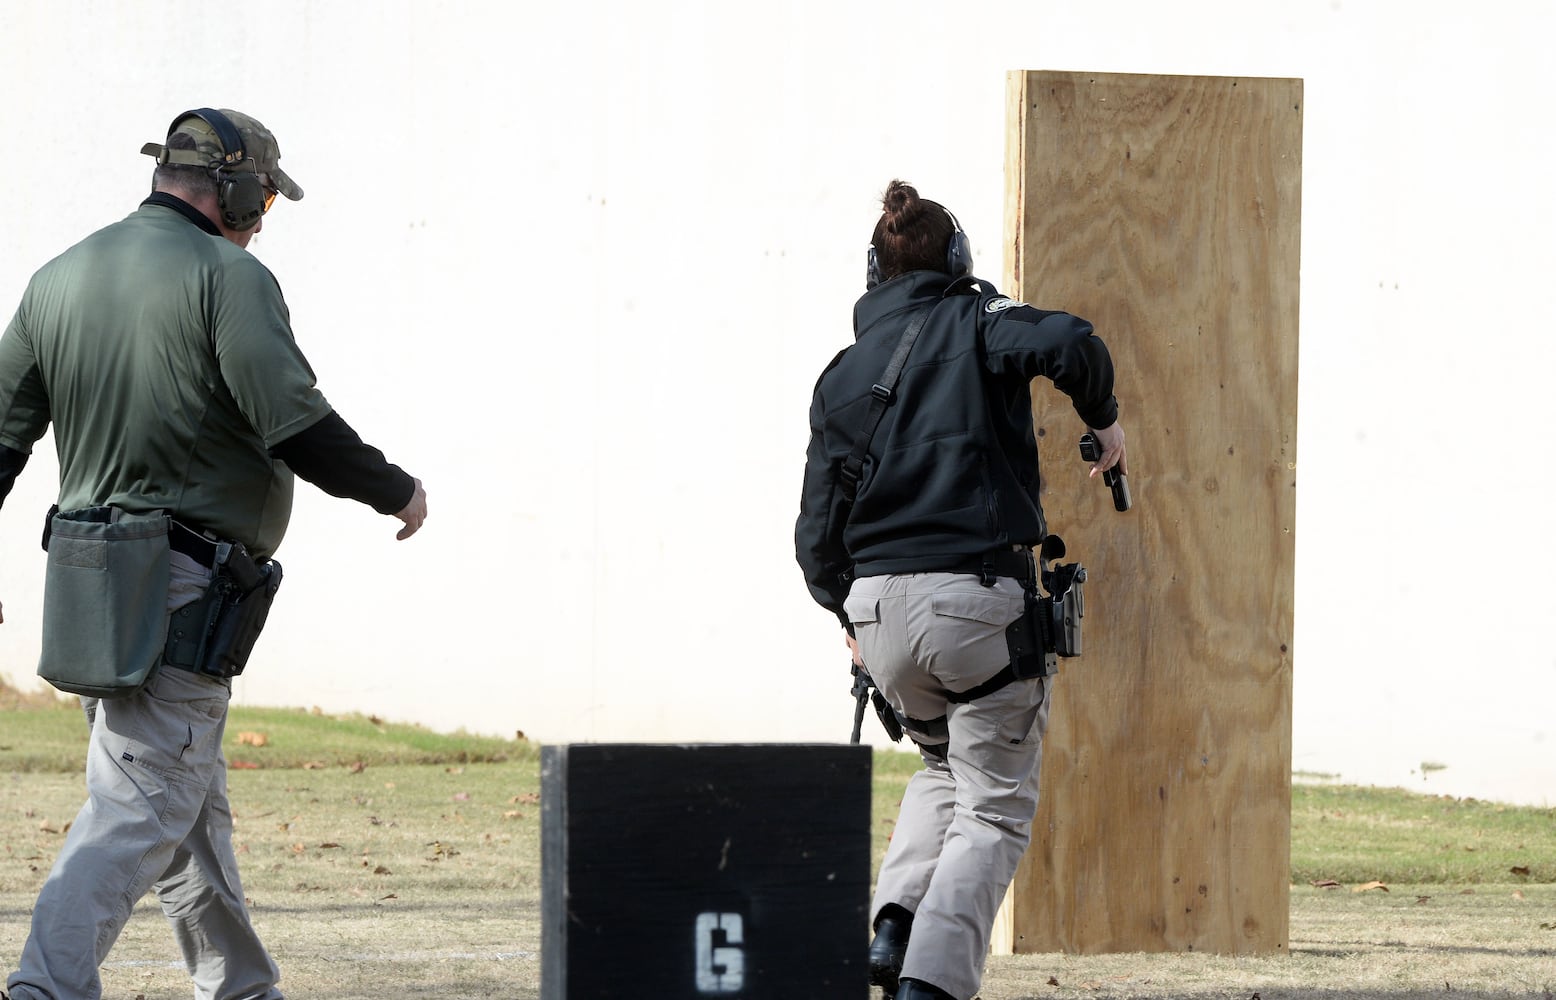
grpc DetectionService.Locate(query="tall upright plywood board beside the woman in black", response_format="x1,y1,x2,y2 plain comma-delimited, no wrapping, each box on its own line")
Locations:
996,72,1302,953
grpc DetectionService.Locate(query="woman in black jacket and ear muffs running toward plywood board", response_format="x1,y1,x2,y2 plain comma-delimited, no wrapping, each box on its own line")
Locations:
795,180,1125,1000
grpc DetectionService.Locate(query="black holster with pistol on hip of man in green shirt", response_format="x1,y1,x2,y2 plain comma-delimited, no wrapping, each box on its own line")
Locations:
163,543,282,678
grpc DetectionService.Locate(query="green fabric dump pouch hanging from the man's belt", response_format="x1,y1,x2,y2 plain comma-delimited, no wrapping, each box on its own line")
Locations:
37,507,170,698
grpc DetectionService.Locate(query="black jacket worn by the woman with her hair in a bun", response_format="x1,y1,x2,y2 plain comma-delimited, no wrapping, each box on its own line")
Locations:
795,271,1119,625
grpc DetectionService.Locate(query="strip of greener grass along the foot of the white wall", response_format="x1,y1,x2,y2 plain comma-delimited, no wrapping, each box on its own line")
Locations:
0,692,1556,886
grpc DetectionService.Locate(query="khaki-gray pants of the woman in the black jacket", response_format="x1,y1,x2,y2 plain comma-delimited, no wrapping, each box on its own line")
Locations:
845,572,1052,1000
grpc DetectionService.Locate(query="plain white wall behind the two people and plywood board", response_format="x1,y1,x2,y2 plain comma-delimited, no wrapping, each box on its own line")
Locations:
0,0,1556,802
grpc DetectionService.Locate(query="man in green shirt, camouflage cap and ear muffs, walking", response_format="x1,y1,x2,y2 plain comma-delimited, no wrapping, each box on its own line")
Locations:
0,107,426,1000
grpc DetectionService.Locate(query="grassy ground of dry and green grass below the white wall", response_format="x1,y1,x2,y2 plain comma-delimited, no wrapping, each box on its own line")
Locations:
0,686,1556,1000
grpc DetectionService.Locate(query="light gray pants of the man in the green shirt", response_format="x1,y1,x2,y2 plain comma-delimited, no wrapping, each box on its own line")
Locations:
9,552,282,1000
